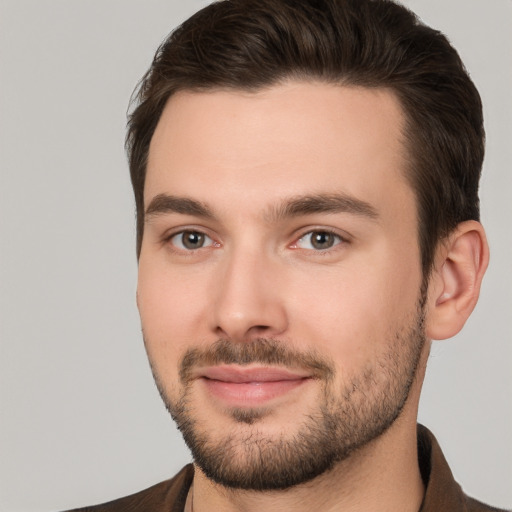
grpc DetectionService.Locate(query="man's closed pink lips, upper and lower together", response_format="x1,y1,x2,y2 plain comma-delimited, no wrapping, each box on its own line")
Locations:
198,365,311,407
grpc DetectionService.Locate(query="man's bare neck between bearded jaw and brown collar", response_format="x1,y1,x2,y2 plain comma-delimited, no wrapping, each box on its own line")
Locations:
191,412,424,512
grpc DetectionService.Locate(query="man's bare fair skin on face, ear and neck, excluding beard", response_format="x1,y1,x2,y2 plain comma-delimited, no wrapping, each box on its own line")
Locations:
137,82,487,512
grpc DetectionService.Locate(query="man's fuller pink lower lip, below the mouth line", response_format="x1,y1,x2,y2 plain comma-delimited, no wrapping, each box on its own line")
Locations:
201,378,310,407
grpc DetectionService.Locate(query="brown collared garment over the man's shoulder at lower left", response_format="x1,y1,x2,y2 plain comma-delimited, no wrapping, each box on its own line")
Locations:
62,464,194,512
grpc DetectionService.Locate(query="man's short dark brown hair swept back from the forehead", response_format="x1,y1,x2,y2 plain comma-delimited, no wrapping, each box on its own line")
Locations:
126,0,485,276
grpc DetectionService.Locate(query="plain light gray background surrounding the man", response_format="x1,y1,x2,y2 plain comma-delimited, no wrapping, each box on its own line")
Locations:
0,0,512,512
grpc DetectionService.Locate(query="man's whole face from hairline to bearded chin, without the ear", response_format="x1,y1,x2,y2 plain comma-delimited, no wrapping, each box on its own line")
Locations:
138,82,424,489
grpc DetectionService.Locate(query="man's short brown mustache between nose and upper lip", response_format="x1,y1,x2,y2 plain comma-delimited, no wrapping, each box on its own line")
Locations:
179,338,335,384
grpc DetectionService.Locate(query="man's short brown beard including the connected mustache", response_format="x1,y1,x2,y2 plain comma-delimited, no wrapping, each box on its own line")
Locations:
146,300,425,491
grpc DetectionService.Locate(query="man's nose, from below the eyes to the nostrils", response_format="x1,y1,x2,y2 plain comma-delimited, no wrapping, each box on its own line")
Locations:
212,252,288,342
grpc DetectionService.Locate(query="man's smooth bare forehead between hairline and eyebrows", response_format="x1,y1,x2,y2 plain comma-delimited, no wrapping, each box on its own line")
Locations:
145,82,412,216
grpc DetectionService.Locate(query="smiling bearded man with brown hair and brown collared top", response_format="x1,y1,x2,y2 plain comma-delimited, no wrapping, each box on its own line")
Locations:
68,0,508,512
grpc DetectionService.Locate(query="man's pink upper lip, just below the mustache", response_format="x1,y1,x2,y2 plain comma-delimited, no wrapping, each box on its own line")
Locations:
197,365,311,383
